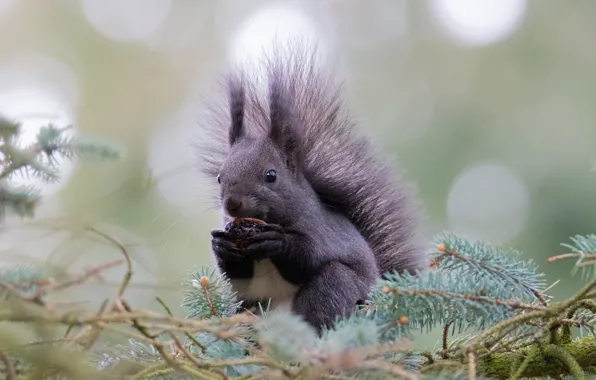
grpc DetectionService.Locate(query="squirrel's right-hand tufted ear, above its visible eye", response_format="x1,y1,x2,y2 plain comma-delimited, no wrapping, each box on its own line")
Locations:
269,75,302,171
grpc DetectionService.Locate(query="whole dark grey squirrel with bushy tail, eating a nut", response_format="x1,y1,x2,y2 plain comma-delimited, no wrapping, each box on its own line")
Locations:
199,40,428,333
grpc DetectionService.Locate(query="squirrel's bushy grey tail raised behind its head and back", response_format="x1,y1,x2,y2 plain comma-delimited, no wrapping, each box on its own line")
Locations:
199,39,428,273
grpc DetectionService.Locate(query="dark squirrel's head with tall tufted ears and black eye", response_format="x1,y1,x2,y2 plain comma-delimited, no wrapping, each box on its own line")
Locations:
217,72,303,224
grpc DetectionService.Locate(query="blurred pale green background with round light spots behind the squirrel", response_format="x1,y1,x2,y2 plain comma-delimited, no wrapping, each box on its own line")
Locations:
0,0,596,345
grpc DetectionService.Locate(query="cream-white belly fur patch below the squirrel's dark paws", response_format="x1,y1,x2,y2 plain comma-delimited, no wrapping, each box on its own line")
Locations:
230,259,299,311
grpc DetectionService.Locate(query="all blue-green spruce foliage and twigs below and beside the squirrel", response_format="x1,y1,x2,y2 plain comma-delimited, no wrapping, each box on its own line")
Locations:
0,113,596,380
